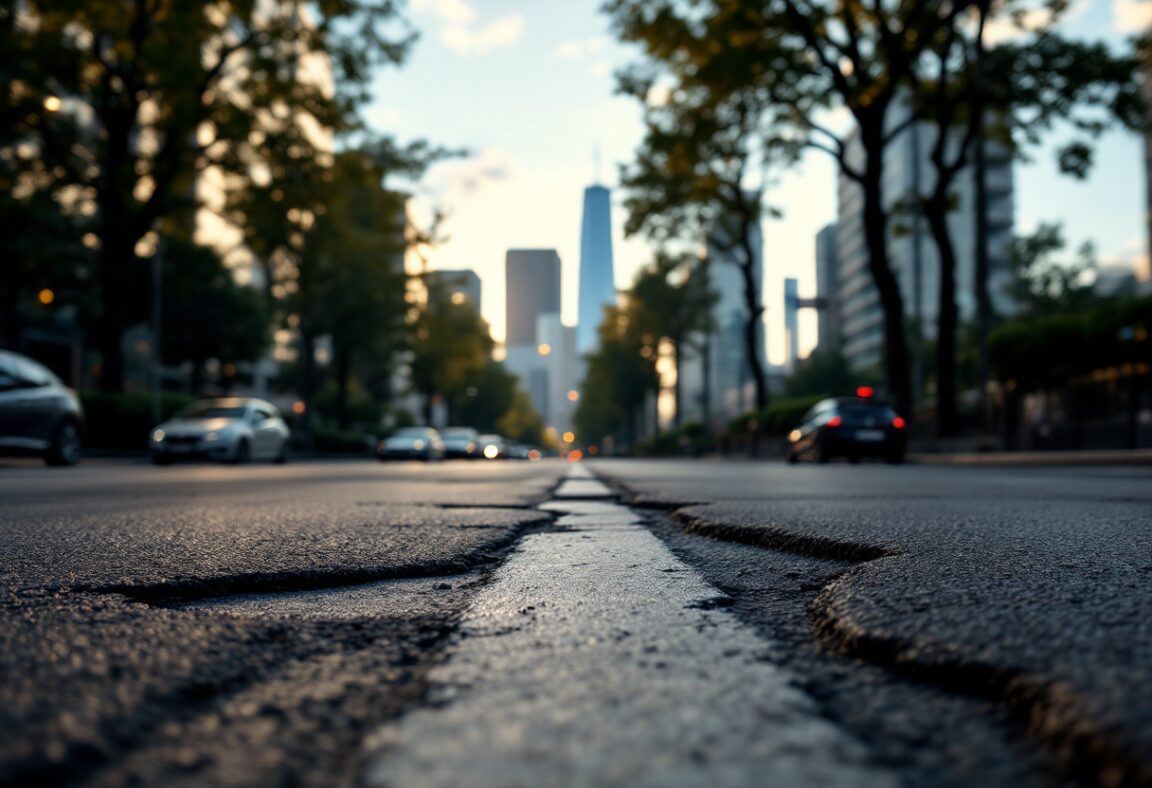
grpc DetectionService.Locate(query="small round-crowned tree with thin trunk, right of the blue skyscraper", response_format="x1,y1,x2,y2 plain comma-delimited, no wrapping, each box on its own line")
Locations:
628,255,717,426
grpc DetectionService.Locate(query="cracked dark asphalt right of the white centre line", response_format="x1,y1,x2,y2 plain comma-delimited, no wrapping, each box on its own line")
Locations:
591,461,1152,786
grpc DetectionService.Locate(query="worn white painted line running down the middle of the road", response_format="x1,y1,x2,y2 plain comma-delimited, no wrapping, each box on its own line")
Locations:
365,470,895,788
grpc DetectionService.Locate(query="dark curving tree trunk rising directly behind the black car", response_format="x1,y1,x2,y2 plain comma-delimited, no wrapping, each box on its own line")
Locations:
861,129,915,422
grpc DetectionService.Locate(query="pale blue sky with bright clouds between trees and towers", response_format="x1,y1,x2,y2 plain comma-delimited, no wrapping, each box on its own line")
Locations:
365,0,1152,363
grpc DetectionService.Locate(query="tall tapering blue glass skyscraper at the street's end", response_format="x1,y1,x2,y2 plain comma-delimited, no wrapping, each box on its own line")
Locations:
576,185,616,355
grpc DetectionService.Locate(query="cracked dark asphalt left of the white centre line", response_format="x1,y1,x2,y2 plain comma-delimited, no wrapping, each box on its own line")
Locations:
0,462,566,786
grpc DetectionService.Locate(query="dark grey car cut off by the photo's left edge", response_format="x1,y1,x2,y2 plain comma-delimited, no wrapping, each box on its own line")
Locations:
0,350,84,465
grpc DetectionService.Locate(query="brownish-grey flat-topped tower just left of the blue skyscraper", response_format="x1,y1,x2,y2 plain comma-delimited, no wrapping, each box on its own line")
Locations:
505,249,560,349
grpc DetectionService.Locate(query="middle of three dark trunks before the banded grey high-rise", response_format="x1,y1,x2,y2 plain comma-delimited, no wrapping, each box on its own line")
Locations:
924,188,957,438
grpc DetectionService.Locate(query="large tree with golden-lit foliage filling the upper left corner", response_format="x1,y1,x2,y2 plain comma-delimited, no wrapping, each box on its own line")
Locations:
0,0,412,389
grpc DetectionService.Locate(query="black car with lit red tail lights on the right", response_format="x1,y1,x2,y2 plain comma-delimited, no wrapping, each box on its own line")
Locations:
787,396,905,464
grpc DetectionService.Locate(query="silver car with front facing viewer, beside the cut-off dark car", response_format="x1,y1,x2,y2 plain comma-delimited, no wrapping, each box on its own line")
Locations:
149,397,291,465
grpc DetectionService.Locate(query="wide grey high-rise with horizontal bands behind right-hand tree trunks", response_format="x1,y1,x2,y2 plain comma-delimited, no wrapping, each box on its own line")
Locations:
829,117,1014,370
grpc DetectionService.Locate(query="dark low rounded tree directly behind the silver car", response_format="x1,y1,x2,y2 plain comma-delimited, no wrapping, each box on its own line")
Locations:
160,238,270,394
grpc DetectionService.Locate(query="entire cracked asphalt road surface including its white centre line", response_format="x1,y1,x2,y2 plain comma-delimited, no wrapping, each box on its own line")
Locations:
0,461,1152,786
